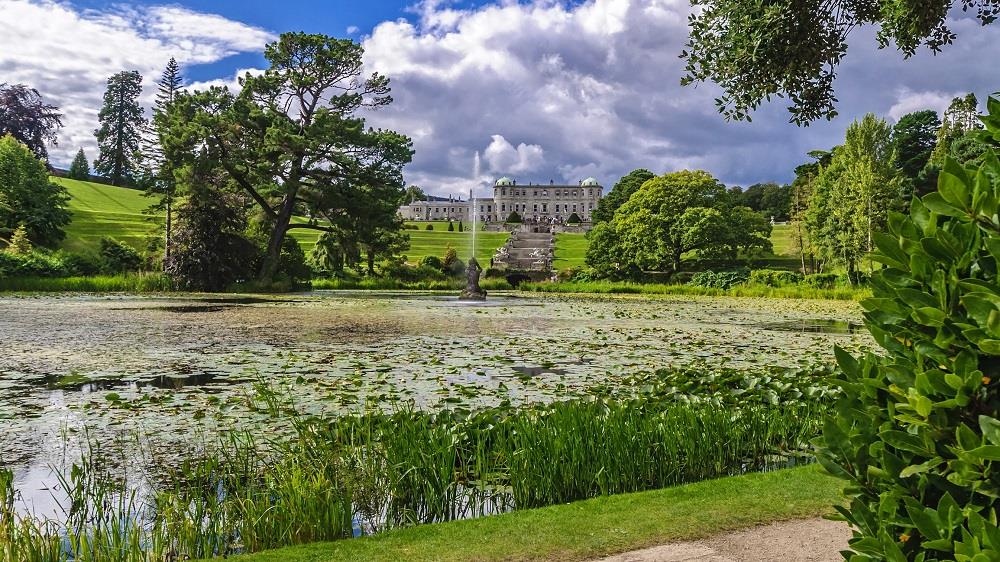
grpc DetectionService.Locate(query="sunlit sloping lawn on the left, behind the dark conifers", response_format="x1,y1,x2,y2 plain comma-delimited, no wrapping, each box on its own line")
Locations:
52,177,162,252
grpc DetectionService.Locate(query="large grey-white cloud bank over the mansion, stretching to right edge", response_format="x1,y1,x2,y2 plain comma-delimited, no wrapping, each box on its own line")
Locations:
364,0,1000,194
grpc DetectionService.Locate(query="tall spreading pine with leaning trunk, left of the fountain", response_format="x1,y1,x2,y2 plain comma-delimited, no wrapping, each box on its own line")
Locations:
164,33,413,284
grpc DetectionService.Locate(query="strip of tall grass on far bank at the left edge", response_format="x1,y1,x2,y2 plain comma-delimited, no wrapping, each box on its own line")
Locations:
0,273,173,293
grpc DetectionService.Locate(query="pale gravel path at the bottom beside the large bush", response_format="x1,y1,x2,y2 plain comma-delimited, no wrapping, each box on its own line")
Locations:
597,519,851,562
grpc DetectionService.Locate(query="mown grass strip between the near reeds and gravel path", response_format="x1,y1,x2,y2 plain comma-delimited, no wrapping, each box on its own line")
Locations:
234,466,843,562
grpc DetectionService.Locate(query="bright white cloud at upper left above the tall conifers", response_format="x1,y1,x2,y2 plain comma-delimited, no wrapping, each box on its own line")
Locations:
0,0,273,165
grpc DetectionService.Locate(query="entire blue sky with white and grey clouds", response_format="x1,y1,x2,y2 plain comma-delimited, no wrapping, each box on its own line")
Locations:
0,0,1000,196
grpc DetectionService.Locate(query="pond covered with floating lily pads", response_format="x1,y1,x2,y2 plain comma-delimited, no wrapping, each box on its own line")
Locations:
0,292,872,512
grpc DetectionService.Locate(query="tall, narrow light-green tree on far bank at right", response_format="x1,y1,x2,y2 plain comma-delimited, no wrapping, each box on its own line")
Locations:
807,113,903,282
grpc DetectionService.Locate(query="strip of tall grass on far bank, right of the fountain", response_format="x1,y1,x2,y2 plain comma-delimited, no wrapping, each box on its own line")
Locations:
518,281,871,301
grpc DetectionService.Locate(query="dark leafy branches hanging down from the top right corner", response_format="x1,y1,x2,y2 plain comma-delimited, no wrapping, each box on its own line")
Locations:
681,0,1000,125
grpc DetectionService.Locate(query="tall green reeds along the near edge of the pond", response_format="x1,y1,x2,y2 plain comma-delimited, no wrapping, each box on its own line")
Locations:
0,397,823,562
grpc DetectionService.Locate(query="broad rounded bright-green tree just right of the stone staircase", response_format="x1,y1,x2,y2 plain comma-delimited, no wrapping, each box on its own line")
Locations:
587,170,770,271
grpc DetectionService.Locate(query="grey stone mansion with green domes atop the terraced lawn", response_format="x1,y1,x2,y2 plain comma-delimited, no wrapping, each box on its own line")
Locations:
399,177,604,224
